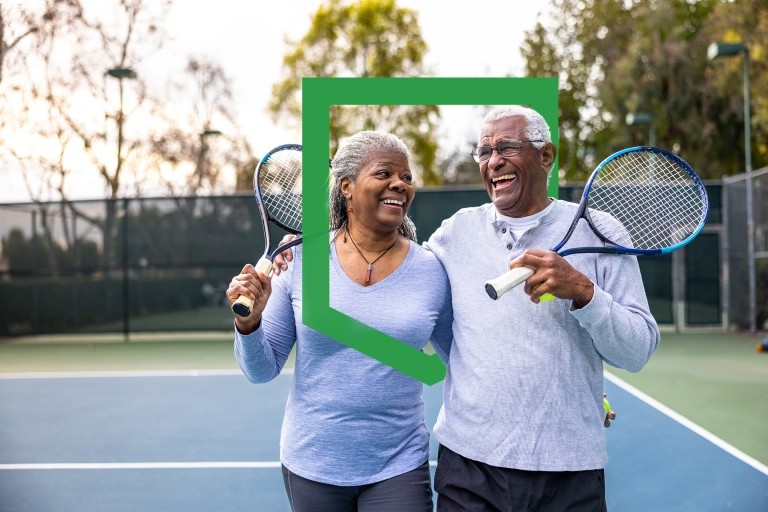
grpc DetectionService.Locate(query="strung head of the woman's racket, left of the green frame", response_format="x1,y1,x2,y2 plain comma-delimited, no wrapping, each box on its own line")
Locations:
253,144,302,235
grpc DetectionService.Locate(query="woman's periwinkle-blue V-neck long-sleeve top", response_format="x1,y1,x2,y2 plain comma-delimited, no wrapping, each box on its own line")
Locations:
235,238,452,485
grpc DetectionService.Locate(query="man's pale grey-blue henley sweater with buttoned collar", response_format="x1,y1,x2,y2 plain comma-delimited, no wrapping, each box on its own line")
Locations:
425,201,659,471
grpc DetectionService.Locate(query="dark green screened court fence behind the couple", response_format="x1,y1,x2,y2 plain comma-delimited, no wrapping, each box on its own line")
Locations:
0,184,728,338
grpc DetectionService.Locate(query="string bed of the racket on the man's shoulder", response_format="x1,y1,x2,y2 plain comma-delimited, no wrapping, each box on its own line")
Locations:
589,152,707,249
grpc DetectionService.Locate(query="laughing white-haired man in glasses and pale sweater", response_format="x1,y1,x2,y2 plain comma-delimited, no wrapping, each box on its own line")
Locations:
425,106,659,512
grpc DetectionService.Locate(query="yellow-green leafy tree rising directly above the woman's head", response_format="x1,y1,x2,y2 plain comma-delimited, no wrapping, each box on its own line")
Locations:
269,0,440,185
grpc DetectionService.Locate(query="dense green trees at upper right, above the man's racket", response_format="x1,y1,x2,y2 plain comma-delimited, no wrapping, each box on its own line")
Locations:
522,0,768,181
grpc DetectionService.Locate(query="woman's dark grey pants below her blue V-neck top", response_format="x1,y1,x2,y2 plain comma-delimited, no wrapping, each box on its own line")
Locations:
283,462,433,512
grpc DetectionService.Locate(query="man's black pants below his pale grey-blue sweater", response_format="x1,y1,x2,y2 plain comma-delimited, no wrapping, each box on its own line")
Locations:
435,445,607,512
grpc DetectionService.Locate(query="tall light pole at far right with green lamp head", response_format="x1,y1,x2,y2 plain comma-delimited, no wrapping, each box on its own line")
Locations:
707,43,757,333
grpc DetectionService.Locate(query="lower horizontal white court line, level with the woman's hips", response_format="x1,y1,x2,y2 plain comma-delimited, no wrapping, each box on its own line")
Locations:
0,460,437,471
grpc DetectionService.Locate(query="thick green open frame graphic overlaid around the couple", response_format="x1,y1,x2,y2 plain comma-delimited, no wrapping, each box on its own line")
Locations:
302,77,558,385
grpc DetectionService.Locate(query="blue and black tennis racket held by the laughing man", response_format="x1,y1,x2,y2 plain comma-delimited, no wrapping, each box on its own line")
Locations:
485,146,709,300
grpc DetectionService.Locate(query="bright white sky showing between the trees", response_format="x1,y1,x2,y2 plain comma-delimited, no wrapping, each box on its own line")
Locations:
0,0,547,202
